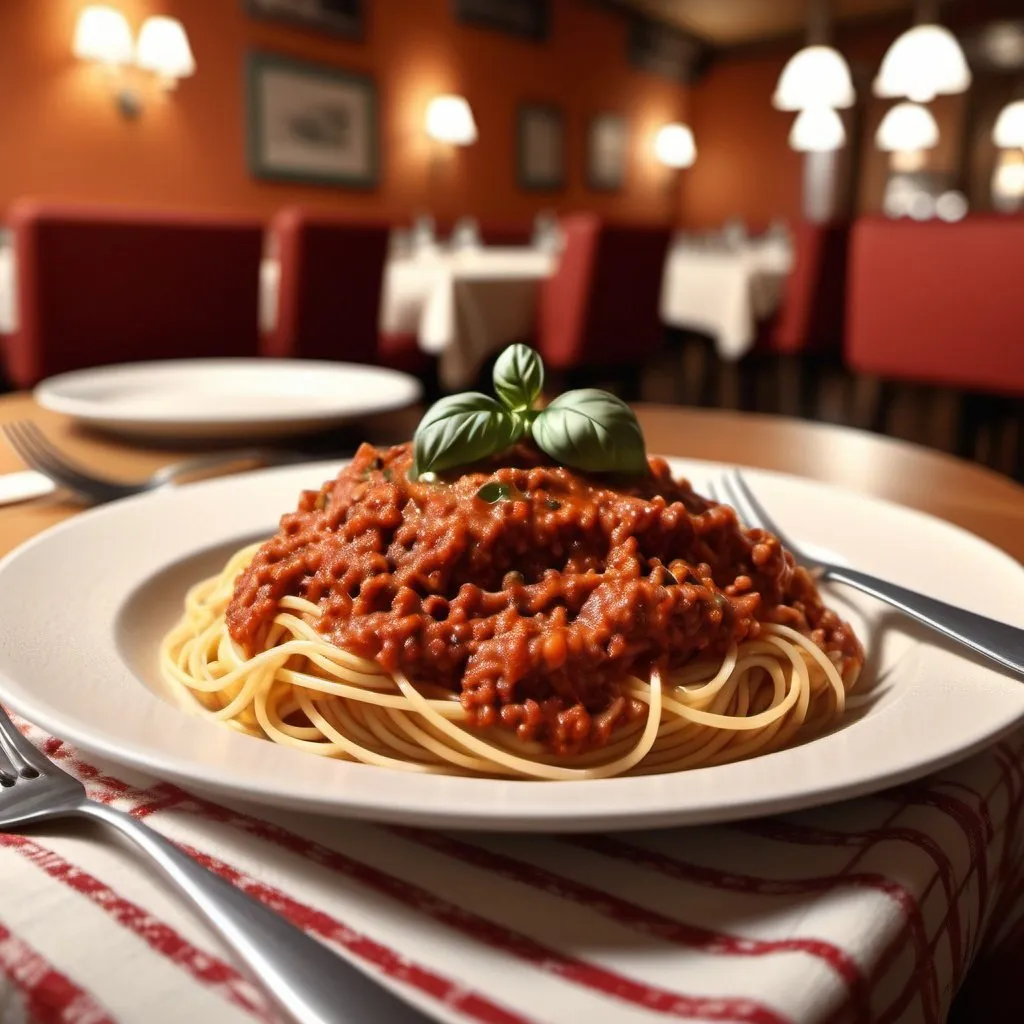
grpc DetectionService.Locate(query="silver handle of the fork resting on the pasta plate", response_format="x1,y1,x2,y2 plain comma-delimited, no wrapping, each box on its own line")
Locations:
825,565,1024,676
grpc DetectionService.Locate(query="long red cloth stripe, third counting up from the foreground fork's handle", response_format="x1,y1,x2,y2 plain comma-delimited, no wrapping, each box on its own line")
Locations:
388,825,867,1016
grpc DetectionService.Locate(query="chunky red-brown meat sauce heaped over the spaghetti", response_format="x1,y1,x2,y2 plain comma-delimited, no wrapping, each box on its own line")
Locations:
227,444,862,754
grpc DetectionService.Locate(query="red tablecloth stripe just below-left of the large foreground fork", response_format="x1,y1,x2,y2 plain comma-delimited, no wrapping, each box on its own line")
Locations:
0,835,274,1021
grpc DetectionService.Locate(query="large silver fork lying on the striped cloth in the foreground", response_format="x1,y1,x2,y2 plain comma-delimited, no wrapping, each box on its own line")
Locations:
0,708,426,1024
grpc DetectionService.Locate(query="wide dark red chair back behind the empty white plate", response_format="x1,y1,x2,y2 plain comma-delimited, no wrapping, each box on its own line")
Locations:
6,201,263,387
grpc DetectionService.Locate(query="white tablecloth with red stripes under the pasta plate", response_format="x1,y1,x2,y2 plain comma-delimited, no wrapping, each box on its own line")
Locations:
0,727,1024,1024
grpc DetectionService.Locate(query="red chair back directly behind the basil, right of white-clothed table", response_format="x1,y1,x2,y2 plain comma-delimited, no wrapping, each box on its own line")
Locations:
537,215,670,370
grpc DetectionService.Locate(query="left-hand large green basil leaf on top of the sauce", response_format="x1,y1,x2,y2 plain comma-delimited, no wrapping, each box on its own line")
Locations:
413,391,525,476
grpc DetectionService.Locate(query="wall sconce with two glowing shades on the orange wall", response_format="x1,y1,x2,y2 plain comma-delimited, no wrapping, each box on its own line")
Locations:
72,4,196,118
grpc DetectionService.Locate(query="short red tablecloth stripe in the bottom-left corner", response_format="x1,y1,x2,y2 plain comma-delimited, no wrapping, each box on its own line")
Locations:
0,924,117,1024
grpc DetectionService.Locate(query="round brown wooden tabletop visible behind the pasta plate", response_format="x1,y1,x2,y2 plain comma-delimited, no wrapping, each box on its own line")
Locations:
0,394,1024,561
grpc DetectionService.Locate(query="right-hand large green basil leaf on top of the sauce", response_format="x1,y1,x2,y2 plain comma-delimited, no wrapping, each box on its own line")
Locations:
532,388,647,474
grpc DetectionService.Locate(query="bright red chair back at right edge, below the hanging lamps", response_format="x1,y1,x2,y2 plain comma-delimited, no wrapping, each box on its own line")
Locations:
846,216,1024,394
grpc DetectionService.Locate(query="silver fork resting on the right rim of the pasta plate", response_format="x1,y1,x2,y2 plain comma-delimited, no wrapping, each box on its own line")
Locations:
706,469,1024,676
